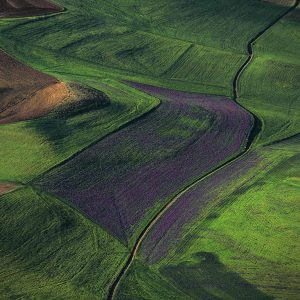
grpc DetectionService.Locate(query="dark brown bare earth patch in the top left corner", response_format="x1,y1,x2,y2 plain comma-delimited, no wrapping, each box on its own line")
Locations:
0,0,63,18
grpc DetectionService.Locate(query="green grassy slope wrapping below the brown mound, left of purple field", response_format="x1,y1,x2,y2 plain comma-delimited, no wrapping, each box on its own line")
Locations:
0,81,159,182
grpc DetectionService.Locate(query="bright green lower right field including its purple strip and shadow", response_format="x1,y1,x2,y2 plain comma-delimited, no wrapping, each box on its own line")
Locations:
116,137,300,299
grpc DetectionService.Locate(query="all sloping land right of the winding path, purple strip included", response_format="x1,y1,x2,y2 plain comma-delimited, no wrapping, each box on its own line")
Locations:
116,2,299,299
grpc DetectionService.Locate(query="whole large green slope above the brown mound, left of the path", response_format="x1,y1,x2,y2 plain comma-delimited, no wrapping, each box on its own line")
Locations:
1,0,284,95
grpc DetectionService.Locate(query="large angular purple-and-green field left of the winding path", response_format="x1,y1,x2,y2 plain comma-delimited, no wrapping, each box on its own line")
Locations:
36,83,253,245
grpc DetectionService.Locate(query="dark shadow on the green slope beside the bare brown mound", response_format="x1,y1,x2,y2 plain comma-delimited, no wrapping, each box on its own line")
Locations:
27,85,126,152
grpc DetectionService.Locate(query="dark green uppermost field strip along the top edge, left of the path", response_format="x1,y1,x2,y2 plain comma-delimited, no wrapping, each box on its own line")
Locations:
60,0,286,53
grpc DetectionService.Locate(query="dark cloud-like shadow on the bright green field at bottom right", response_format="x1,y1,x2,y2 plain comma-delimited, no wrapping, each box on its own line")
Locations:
160,252,273,300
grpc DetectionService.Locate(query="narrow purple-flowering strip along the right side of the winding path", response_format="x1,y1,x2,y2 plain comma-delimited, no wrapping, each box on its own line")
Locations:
142,152,262,263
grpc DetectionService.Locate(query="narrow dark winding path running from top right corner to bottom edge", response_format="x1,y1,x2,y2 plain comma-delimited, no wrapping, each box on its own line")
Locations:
107,0,300,300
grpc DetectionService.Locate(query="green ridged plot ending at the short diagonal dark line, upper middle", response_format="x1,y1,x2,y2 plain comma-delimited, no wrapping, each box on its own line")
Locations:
58,26,190,76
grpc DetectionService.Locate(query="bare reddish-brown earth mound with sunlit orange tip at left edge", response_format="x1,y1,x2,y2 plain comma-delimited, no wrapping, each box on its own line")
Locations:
0,51,69,124
